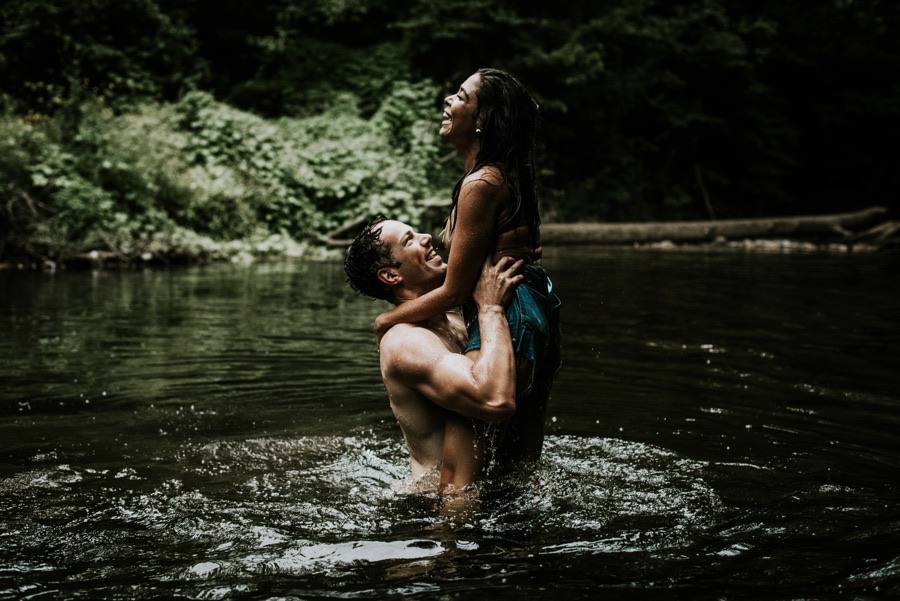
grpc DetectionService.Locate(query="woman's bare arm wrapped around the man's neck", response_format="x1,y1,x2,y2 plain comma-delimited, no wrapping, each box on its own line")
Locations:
375,168,503,340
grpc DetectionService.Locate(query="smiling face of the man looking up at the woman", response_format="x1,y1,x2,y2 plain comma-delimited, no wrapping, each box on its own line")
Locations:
380,220,447,294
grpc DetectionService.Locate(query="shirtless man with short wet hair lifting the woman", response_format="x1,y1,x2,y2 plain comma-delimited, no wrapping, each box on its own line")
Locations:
344,216,555,502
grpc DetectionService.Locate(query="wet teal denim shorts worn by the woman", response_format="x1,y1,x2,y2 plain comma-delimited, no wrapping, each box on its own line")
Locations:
463,265,561,399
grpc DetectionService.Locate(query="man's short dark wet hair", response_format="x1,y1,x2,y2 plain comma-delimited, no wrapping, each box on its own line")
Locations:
344,215,400,302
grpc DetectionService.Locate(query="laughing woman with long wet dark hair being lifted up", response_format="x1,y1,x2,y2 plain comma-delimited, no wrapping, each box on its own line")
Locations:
375,69,559,460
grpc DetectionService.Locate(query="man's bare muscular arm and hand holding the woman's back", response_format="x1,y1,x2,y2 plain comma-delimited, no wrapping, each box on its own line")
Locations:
382,257,522,421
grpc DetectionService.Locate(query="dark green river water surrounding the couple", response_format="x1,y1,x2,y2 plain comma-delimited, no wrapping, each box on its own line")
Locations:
0,247,900,600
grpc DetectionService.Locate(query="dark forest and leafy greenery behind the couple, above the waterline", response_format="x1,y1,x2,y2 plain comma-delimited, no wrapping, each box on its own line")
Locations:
0,0,900,262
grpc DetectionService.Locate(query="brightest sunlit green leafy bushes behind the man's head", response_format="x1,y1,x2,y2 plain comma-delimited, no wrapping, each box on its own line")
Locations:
176,84,446,238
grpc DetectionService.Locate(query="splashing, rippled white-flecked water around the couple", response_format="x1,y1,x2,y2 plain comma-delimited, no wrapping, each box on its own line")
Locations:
0,436,719,578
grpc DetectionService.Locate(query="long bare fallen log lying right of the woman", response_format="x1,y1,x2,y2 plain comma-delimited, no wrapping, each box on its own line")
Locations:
541,207,887,245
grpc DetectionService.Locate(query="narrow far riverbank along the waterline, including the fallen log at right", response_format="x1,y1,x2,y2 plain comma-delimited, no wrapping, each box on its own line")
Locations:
0,207,900,271
